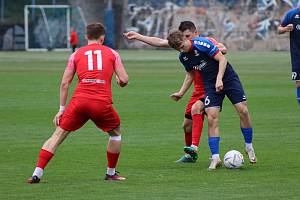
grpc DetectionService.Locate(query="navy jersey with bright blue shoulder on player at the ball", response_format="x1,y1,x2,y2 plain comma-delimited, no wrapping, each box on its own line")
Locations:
179,37,237,88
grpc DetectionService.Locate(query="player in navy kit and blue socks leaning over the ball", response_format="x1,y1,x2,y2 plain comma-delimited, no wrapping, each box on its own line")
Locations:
168,31,256,170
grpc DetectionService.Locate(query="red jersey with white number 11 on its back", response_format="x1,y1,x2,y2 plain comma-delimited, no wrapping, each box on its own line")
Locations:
73,43,116,103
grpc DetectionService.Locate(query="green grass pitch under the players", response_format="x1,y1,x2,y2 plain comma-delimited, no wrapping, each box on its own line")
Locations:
0,50,300,200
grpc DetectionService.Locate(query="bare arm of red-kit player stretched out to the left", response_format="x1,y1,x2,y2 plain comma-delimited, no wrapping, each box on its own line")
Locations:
124,31,169,48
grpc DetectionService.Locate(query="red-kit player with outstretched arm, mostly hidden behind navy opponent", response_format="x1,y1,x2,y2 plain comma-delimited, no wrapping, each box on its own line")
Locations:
124,21,227,163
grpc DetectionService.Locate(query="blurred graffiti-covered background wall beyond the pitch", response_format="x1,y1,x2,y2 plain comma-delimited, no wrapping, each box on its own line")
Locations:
0,0,300,50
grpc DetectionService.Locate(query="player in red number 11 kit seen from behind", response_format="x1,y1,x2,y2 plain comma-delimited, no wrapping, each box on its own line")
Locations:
27,23,128,184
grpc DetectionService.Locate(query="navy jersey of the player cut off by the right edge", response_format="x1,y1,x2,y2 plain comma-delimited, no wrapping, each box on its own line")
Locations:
281,8,300,67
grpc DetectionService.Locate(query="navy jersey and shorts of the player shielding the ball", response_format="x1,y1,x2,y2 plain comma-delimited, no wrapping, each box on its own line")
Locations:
179,37,246,108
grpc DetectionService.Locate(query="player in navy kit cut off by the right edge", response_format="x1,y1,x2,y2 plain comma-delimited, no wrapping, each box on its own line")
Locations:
278,6,300,106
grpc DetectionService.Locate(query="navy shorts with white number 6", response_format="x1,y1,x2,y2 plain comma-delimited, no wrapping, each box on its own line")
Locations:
204,77,247,108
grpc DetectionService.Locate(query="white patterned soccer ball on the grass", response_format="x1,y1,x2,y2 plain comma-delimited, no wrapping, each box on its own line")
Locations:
224,150,244,169
